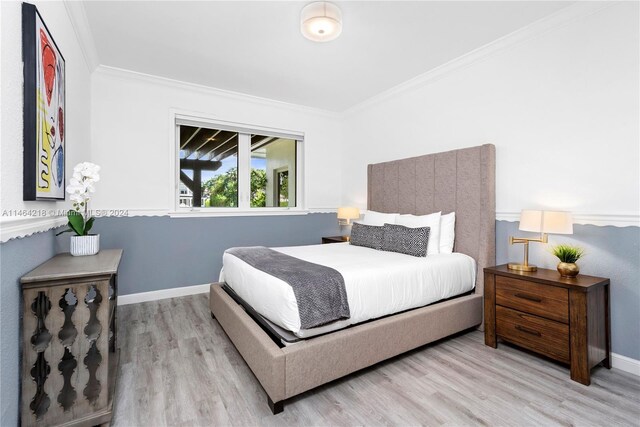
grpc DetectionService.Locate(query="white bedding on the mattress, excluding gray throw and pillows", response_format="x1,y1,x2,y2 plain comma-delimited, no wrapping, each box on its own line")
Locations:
220,243,476,338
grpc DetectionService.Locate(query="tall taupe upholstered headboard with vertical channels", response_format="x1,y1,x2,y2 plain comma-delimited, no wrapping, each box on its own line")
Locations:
367,144,496,294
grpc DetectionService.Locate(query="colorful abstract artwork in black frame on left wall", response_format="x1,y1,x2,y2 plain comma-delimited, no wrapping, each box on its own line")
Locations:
22,3,66,200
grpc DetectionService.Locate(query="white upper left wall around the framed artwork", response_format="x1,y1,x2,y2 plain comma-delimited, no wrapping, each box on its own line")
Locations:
0,1,91,217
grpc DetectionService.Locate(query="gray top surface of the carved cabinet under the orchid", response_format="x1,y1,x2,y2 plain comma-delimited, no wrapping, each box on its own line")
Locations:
20,249,122,284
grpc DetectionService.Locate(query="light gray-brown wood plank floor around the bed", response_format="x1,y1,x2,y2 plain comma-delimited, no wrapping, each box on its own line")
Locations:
113,294,640,427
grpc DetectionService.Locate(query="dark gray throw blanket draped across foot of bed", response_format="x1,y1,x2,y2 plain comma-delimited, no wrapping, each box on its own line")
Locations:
226,246,351,329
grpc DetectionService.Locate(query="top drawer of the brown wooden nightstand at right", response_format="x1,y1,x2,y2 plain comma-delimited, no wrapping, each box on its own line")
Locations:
496,276,569,323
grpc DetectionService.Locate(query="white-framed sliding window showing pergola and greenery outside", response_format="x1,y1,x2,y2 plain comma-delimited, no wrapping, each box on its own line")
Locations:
175,117,302,212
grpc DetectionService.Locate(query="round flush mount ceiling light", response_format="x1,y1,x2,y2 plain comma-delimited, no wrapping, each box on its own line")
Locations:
300,1,342,42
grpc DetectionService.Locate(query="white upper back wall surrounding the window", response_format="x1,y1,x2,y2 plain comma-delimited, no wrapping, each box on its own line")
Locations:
91,67,342,215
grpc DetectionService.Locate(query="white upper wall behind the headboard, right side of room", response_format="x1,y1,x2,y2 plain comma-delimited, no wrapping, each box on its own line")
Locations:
343,2,640,224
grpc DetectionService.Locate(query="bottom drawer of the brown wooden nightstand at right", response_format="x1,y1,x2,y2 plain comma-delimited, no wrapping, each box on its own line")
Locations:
496,306,570,363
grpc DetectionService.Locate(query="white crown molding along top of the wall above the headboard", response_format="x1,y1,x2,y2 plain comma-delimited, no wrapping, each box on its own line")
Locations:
343,1,622,116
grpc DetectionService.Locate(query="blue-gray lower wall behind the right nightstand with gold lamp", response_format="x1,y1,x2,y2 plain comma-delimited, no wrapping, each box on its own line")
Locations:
496,221,640,360
